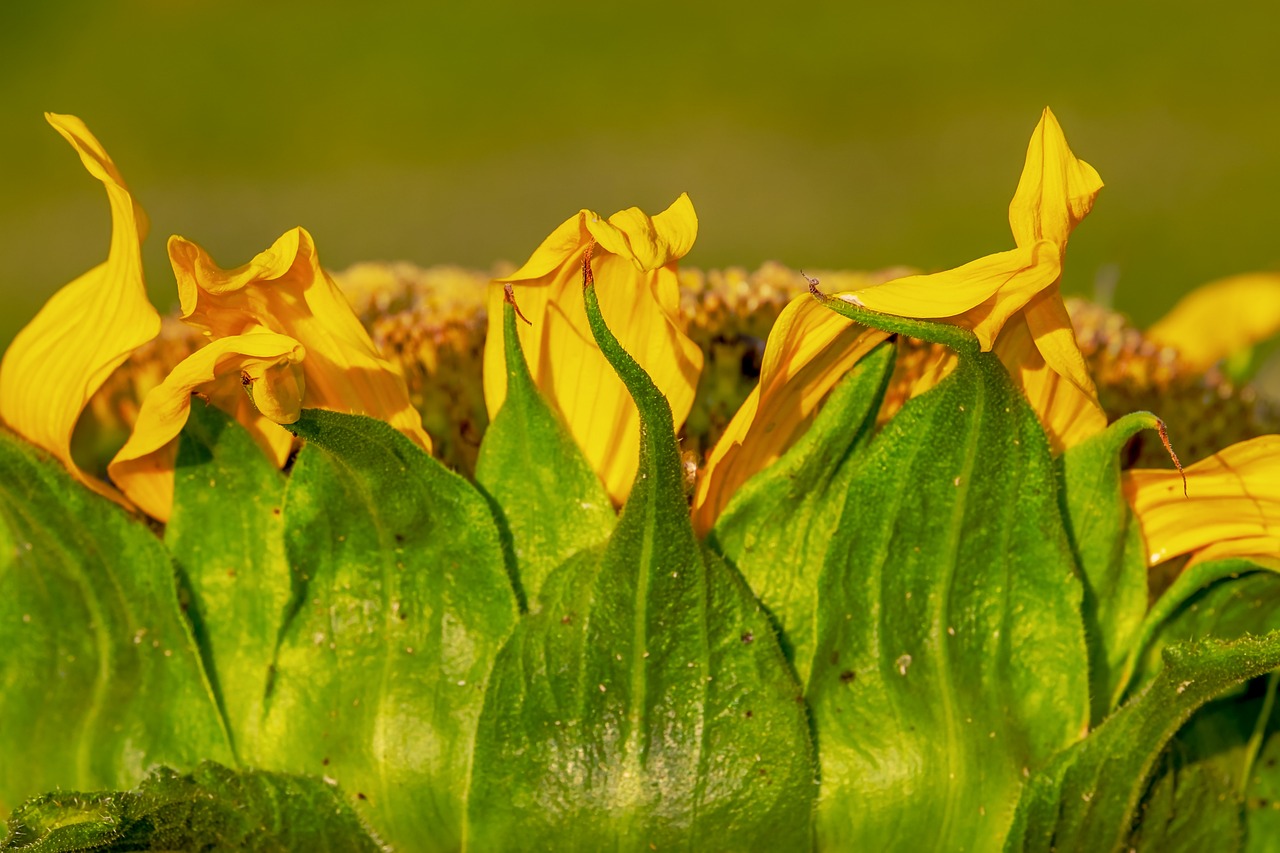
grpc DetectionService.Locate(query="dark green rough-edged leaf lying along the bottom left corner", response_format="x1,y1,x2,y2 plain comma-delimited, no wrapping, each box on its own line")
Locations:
0,762,383,853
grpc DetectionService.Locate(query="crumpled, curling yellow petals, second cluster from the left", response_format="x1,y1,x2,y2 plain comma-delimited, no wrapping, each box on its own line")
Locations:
108,228,431,520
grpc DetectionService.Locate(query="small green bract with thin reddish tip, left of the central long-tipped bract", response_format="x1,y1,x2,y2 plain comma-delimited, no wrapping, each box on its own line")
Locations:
476,295,617,601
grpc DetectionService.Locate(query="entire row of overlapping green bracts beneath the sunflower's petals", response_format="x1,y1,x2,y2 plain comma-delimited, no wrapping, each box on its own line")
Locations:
0,294,1280,850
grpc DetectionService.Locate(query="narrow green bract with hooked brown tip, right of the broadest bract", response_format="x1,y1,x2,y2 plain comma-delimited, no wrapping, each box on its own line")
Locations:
1059,412,1161,725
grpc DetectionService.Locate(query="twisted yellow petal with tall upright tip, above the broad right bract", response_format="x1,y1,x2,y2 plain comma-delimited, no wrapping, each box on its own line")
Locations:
838,108,1106,451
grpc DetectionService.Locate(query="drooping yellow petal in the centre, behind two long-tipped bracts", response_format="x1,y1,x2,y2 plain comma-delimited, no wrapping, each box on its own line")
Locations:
484,195,703,503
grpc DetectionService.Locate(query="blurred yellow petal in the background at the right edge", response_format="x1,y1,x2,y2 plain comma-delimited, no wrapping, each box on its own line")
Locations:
1147,273,1280,371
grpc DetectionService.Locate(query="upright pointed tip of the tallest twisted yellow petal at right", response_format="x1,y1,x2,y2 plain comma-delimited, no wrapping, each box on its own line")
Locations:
1009,106,1102,248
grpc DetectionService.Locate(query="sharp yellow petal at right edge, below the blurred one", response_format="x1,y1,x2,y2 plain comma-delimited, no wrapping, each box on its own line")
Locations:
1124,435,1280,565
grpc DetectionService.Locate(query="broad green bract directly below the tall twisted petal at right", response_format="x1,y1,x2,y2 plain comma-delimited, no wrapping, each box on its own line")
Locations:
806,342,1088,849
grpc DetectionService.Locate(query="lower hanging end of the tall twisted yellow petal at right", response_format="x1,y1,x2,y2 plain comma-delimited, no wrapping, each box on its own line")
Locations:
996,316,1107,453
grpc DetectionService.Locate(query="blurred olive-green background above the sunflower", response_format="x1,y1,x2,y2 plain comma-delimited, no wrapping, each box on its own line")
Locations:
0,0,1280,345
